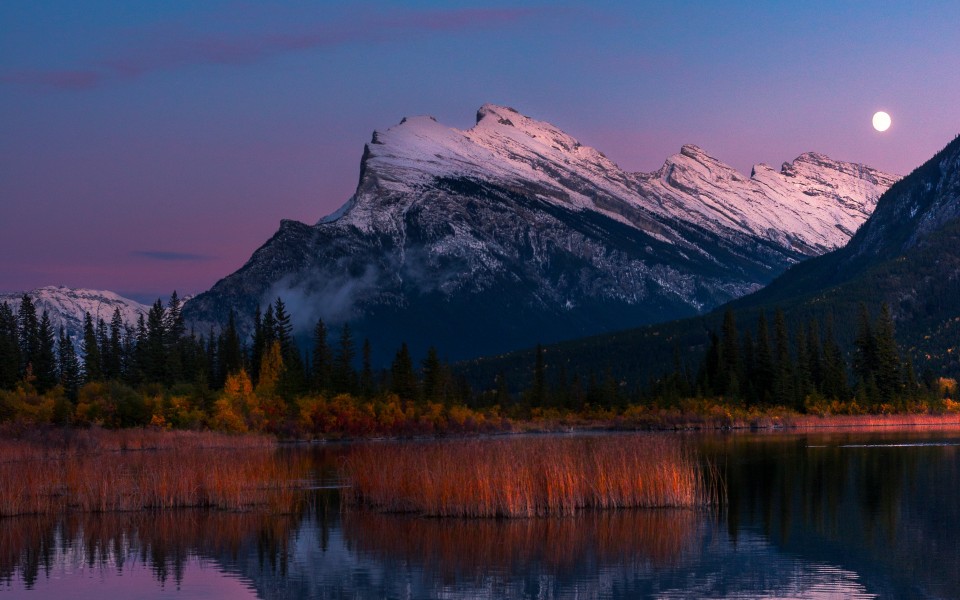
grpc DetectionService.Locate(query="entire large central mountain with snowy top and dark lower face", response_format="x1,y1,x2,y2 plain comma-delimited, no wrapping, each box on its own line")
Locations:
184,105,896,360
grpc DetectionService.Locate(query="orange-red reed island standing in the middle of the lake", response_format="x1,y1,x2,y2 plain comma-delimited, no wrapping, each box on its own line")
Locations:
342,434,717,517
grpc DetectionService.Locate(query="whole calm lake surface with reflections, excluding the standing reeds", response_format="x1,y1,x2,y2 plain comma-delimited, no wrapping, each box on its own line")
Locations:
0,431,960,599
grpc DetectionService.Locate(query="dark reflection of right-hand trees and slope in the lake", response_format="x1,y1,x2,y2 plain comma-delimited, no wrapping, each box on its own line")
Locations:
711,431,960,598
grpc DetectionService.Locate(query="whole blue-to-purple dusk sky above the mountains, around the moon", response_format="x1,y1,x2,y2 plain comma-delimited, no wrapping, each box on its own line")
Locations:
0,0,960,299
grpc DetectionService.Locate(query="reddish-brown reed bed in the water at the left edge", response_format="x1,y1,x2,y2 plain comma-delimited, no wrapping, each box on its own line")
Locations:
0,430,307,516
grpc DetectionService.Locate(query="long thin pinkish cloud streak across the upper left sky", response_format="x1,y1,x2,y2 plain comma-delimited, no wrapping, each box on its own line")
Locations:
0,8,544,90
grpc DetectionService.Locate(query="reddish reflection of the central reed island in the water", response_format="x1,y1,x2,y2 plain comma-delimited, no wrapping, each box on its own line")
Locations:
343,509,705,578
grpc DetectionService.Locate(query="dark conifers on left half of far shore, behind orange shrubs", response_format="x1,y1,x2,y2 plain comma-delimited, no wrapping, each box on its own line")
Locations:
0,292,471,404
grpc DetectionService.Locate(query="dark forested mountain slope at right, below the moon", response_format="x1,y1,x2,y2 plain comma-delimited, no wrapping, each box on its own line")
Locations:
461,137,960,389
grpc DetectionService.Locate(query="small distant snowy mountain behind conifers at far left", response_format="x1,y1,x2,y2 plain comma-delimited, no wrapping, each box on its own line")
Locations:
0,286,150,339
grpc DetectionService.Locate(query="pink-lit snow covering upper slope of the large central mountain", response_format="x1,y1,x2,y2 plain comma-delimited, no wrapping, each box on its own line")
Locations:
334,104,897,255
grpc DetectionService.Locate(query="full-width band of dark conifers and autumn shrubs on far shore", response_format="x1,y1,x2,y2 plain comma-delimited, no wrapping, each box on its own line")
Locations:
0,292,936,431
